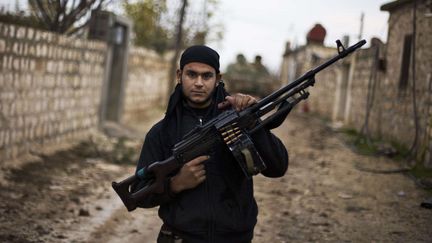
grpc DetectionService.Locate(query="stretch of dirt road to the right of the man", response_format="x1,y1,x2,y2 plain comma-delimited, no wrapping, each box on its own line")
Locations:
255,116,432,242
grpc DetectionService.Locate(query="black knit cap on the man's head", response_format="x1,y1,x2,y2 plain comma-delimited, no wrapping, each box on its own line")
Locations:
180,45,220,73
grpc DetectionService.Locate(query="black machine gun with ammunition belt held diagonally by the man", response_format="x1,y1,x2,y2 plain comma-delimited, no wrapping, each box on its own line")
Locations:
112,40,366,211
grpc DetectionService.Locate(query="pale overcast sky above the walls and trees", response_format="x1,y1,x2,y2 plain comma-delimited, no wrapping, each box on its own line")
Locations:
0,0,391,73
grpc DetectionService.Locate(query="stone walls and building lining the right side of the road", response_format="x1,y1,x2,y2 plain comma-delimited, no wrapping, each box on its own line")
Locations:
282,1,432,166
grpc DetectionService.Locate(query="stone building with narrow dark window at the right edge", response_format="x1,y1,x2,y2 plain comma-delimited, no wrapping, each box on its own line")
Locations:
380,1,432,162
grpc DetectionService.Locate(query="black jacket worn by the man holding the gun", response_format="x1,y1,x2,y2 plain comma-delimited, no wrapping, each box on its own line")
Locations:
137,83,288,242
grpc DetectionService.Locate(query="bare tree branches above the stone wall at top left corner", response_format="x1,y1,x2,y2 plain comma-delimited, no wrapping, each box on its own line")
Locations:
28,0,111,35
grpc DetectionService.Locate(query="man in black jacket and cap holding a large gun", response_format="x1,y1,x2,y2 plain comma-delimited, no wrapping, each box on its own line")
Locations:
135,46,288,243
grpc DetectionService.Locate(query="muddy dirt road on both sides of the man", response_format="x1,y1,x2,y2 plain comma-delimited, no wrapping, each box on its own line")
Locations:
0,114,432,243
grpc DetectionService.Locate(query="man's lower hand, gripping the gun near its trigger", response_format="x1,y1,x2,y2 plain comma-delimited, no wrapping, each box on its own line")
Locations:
170,156,209,193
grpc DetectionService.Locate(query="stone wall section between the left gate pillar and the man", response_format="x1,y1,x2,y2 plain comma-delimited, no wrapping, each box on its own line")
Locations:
123,47,174,123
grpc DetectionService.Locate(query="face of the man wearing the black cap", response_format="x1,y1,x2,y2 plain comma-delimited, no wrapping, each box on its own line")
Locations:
177,62,220,108
